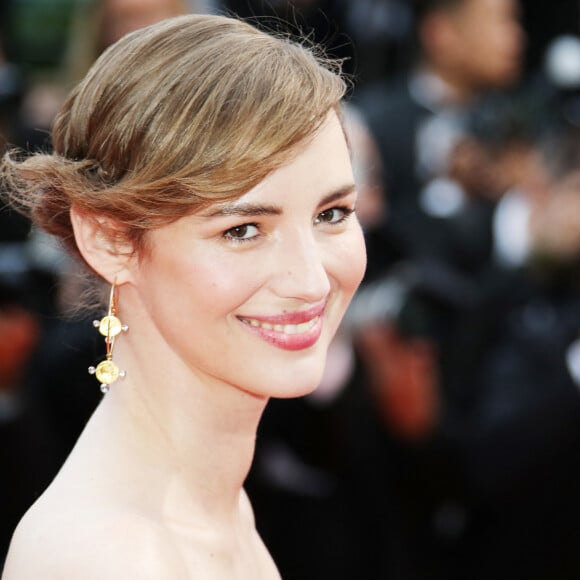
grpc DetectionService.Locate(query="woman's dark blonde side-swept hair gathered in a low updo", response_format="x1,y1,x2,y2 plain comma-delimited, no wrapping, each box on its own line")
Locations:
1,15,345,260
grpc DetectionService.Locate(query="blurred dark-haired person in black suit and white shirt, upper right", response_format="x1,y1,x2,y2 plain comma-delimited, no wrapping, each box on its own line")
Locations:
355,0,524,255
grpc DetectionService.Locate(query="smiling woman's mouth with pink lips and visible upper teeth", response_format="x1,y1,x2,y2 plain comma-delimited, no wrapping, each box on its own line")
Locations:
238,304,325,350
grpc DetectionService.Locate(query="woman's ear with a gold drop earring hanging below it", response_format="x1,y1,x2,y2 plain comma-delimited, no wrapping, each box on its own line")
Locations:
70,206,134,285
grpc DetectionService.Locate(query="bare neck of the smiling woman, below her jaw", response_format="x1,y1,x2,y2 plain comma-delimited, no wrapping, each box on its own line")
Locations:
73,340,266,523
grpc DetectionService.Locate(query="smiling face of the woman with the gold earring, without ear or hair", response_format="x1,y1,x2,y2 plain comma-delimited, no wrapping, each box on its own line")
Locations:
121,113,365,397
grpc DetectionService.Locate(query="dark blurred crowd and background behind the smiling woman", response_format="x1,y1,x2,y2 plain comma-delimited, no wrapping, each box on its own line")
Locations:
0,0,580,580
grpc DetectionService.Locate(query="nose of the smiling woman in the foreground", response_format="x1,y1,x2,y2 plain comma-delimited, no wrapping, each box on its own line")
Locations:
270,232,331,303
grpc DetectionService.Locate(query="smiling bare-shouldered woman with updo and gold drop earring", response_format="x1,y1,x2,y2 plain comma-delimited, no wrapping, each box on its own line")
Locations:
2,10,365,580
